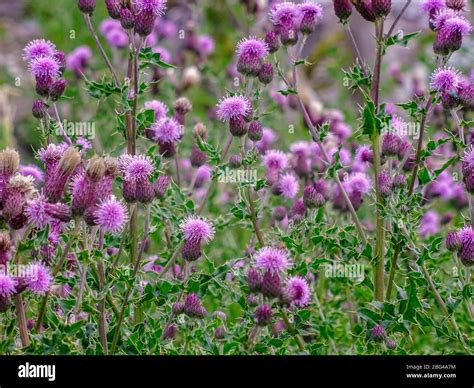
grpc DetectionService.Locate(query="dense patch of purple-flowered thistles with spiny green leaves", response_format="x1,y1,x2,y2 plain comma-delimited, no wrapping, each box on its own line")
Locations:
0,0,474,355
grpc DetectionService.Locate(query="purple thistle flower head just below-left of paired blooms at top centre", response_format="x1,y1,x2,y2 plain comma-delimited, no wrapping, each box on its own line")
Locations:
237,36,269,76
